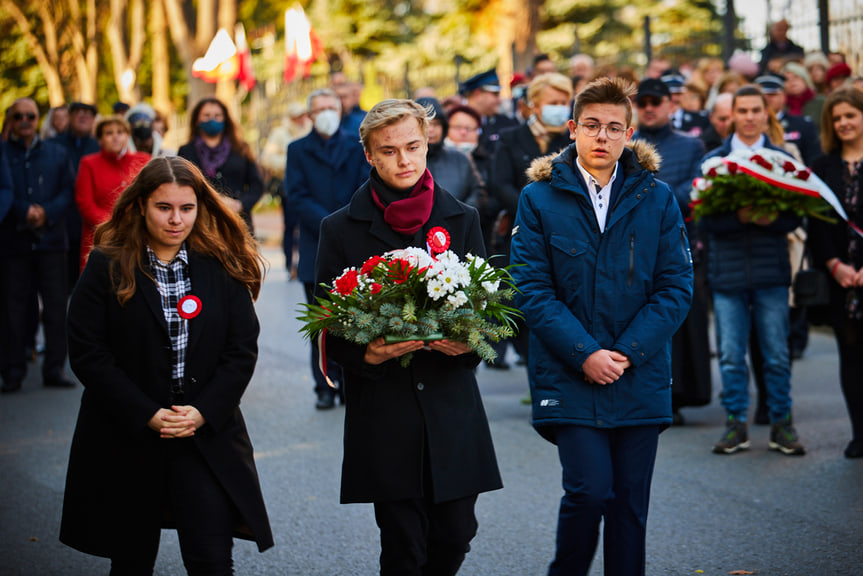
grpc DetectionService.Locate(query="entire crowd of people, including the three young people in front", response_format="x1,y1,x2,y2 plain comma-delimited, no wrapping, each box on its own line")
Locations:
0,16,863,575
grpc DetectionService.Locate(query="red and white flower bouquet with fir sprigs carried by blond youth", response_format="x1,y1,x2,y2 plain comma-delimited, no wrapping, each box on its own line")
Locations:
298,228,521,366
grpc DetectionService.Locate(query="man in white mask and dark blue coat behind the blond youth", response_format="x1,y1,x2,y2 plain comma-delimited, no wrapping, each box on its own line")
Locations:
285,89,369,410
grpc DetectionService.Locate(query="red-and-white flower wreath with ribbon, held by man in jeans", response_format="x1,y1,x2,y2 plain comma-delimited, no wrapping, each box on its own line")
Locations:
691,148,832,221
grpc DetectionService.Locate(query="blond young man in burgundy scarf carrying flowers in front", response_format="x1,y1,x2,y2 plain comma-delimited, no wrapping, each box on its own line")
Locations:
316,100,502,575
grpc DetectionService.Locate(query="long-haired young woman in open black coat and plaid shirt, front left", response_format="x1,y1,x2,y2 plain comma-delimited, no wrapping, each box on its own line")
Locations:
60,157,273,575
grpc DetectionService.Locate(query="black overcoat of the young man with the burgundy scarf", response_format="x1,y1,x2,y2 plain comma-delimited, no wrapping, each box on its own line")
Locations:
316,182,503,503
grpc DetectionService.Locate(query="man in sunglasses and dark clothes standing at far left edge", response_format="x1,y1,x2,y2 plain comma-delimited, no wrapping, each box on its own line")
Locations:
0,98,75,392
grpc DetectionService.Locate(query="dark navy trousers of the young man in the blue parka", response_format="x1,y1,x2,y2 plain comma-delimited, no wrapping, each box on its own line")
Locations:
548,425,659,576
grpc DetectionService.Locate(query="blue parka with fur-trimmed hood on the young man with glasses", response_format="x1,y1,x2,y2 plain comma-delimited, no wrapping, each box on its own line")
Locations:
512,142,692,441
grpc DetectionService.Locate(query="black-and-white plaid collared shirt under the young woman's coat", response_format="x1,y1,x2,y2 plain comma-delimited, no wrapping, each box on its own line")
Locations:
147,244,192,402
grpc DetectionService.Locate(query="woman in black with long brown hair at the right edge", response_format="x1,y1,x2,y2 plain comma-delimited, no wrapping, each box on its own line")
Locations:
809,86,863,458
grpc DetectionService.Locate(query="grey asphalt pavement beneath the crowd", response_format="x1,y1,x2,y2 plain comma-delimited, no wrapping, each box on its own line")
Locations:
0,248,863,576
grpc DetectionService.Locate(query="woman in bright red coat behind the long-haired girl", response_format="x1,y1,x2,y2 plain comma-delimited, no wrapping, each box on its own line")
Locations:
75,116,150,270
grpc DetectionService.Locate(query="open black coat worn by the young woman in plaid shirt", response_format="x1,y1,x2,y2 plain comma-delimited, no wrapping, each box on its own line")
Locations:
60,250,273,557
